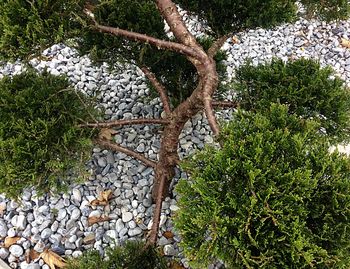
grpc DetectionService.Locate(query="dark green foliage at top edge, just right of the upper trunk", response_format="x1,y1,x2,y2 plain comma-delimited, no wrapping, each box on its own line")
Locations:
174,0,297,36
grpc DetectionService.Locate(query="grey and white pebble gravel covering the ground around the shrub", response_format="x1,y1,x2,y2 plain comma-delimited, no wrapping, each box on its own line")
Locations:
0,9,350,269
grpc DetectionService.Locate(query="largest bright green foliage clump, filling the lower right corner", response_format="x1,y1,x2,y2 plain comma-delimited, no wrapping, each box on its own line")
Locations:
175,104,350,269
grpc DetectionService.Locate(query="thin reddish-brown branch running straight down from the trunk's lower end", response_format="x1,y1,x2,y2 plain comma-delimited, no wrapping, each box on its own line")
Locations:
149,175,167,245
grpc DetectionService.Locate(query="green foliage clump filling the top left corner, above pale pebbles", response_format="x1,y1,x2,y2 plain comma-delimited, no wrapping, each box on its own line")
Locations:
0,0,81,61
